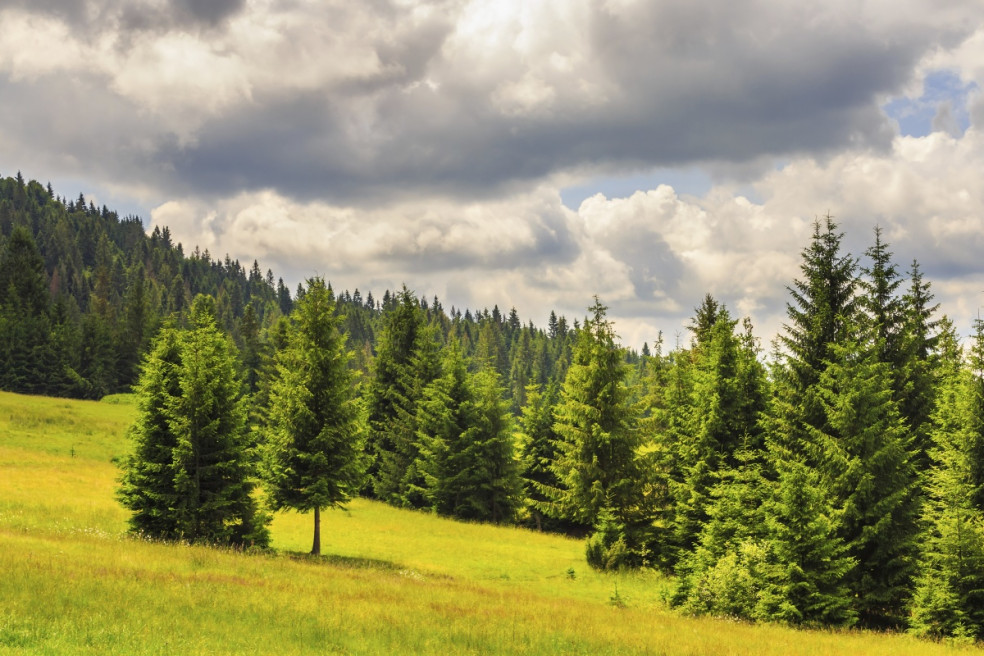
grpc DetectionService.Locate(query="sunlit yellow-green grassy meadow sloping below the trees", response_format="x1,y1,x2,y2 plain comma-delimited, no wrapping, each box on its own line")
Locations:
0,386,980,656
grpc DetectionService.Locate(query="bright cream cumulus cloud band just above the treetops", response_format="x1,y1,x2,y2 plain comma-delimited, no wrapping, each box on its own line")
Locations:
144,121,984,347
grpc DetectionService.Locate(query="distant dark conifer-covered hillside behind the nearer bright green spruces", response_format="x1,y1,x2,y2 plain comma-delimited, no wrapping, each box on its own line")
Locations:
0,173,592,402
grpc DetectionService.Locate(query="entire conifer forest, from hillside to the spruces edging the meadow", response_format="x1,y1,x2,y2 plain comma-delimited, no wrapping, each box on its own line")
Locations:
0,176,984,640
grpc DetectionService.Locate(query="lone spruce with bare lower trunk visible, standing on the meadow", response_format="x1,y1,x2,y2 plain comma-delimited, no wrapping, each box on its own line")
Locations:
267,278,364,555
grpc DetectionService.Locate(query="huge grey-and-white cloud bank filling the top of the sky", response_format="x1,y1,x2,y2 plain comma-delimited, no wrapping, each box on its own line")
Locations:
0,0,984,206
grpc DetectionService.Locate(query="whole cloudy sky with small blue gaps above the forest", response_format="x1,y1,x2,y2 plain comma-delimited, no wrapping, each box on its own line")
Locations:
0,0,984,348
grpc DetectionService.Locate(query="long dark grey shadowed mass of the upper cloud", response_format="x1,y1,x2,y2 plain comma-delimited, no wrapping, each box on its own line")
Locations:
131,2,968,202
